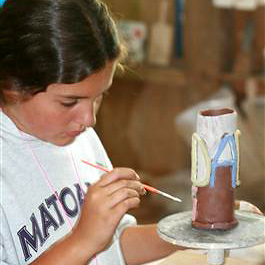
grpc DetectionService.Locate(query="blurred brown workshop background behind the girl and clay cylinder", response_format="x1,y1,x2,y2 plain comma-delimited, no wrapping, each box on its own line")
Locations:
96,0,265,223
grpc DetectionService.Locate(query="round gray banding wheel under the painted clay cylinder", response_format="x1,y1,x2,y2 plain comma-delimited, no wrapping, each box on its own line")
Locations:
157,211,265,265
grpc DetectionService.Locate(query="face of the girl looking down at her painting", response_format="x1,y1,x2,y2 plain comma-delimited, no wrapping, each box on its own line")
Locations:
3,62,116,146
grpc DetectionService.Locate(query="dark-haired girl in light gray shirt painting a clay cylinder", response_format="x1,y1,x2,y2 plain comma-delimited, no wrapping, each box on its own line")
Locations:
0,0,179,265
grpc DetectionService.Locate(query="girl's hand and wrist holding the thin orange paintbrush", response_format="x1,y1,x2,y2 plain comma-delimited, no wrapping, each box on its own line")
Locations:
73,168,145,254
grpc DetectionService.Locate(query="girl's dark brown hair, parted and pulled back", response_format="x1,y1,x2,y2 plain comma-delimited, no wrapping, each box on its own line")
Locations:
0,0,121,104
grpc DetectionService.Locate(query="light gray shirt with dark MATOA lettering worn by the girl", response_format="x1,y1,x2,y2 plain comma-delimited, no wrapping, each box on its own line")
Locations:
0,112,136,265
